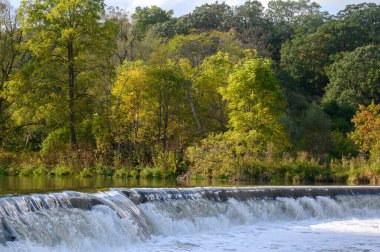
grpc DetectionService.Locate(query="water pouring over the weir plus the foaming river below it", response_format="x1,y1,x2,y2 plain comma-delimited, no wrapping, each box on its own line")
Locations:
0,186,380,252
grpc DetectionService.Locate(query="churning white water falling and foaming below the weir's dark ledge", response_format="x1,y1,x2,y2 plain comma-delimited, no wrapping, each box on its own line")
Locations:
0,192,380,252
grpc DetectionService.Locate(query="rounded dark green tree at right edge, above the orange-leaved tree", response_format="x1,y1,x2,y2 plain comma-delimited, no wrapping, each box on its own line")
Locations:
324,45,380,107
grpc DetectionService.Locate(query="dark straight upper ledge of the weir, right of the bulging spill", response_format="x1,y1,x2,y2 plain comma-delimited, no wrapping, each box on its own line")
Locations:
120,186,380,204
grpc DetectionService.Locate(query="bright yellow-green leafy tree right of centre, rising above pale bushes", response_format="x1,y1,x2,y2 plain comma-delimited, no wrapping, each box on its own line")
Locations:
221,54,288,151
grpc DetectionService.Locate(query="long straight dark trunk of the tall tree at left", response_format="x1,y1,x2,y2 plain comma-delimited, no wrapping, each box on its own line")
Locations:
68,41,78,149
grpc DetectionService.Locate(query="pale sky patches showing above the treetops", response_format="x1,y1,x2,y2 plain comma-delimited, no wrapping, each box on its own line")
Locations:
10,0,380,16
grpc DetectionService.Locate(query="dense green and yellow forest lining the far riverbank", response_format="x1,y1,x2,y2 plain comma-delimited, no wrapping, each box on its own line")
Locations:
0,0,380,183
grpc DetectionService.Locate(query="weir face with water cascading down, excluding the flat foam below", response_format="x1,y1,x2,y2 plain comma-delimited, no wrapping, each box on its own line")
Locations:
0,186,380,246
